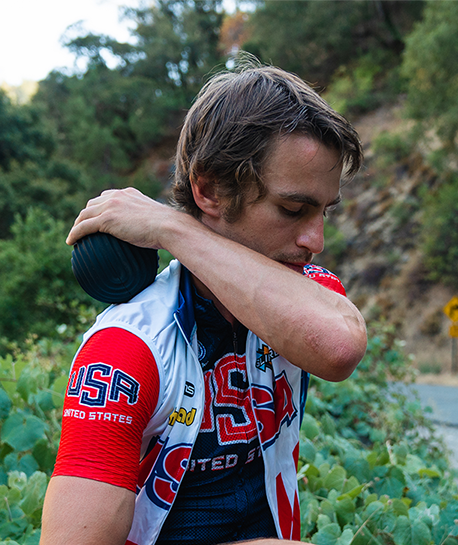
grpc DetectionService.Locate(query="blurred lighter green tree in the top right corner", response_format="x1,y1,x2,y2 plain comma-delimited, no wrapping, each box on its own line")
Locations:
403,0,458,150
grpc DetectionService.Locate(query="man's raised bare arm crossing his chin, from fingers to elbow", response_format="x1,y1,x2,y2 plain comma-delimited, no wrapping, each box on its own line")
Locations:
67,189,366,381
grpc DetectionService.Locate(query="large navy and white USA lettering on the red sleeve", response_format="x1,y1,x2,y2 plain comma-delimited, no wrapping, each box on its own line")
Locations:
67,362,140,407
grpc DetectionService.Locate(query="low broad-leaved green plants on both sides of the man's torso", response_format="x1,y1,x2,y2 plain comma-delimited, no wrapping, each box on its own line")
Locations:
0,318,458,545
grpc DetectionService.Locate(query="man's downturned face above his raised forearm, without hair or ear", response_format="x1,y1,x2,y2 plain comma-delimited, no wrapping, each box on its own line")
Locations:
203,134,342,273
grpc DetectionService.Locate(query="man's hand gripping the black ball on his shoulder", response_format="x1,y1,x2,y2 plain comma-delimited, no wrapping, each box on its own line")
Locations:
66,187,177,249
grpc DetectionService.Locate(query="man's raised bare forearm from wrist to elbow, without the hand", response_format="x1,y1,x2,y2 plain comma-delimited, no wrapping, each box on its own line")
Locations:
161,210,366,380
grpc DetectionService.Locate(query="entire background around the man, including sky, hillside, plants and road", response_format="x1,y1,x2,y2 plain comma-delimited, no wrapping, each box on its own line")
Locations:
0,0,458,545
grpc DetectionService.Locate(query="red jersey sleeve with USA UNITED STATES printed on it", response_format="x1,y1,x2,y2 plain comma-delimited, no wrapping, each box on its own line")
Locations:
53,328,159,492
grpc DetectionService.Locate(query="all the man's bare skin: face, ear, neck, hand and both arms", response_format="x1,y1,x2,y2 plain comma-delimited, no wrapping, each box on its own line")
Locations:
41,135,366,545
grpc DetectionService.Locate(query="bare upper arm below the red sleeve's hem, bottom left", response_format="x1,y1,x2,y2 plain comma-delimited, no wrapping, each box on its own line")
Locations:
40,476,135,545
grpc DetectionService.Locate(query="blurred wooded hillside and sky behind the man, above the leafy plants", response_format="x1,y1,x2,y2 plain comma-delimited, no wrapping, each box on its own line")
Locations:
0,0,458,380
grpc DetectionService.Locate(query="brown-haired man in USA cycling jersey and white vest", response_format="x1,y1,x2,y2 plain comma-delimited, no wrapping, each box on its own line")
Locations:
42,62,366,545
